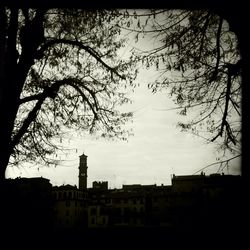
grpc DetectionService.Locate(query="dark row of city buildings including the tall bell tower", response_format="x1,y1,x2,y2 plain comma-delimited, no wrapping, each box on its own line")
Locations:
1,154,243,236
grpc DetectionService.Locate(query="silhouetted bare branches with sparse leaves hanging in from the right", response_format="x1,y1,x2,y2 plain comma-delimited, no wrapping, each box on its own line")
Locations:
118,10,242,161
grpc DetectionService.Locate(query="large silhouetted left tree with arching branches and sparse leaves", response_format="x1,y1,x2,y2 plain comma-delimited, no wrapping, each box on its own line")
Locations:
0,7,136,176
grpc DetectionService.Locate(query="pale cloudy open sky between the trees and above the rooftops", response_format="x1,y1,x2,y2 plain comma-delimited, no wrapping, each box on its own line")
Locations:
6,11,240,188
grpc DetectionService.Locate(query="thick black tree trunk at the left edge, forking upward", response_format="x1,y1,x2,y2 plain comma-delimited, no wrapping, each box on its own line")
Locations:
0,8,45,181
